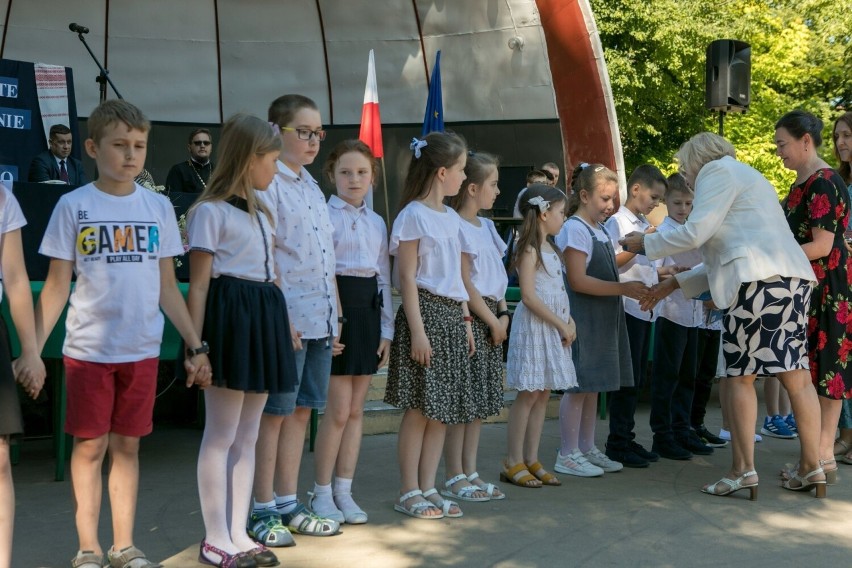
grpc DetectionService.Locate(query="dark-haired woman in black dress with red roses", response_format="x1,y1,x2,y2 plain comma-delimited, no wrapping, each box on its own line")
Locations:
775,110,852,483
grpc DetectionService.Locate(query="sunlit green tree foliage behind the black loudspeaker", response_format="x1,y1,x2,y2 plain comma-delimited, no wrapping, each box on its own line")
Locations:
590,0,852,193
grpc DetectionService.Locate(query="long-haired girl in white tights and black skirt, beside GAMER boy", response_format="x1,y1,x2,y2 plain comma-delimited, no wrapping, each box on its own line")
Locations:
187,115,296,567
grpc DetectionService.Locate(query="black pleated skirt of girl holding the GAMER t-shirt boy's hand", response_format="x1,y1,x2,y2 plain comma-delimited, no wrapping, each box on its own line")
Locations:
202,276,296,394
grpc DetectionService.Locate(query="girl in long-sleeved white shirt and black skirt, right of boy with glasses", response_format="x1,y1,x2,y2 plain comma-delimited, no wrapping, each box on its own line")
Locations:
309,140,393,524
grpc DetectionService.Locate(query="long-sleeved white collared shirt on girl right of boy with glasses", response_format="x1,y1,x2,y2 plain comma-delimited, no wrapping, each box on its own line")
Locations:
328,195,393,339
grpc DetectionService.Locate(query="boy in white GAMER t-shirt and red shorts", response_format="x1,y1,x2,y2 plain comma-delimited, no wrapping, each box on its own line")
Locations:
36,100,211,568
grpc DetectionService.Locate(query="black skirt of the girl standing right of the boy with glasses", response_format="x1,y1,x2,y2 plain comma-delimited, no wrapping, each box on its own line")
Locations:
331,276,382,375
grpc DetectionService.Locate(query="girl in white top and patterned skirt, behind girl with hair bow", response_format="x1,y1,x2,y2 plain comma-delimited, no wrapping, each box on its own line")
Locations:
441,152,509,501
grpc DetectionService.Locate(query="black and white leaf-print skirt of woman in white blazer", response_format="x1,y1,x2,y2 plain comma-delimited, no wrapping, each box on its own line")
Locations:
722,276,813,377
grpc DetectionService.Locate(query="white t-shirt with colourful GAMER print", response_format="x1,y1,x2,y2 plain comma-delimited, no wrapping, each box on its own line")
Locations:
39,183,183,363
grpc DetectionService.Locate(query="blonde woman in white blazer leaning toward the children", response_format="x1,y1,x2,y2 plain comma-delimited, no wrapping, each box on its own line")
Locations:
623,132,825,500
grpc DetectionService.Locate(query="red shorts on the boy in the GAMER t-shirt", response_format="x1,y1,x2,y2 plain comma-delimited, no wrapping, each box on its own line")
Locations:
63,357,159,438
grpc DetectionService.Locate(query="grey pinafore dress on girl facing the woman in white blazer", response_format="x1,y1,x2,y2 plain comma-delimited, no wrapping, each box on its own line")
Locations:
566,216,633,392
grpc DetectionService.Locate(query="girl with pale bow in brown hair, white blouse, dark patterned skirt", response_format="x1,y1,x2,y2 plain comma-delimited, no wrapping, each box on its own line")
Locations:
385,132,474,519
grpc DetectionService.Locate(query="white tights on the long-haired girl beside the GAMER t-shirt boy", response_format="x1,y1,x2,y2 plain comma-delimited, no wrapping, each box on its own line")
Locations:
198,387,267,554
